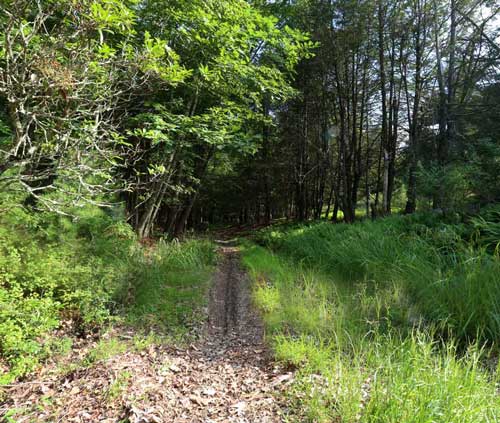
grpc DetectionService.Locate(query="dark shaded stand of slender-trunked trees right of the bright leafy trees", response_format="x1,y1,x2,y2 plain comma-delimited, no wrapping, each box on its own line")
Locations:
193,0,500,230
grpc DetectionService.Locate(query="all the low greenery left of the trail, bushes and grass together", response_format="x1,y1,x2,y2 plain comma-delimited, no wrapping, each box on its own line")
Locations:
0,198,215,385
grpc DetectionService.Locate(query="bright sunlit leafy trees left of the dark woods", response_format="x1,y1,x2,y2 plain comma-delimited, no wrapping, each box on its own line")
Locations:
0,0,312,236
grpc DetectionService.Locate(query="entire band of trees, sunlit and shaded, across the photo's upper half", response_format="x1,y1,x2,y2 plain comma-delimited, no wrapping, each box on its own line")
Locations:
0,0,500,237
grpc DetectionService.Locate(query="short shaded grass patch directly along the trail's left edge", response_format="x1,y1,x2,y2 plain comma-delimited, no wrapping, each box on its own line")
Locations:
128,240,215,341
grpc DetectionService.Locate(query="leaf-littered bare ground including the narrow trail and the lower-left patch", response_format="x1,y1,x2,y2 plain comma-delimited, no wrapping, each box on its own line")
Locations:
0,243,293,423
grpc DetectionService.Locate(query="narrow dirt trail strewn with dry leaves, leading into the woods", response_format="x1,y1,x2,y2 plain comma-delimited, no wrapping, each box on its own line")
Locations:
161,247,283,423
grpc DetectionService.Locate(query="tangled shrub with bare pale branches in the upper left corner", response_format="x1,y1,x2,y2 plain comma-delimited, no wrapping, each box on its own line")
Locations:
0,0,147,203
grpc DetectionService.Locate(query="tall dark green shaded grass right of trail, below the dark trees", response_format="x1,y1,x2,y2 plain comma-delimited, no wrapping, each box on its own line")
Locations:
254,213,500,341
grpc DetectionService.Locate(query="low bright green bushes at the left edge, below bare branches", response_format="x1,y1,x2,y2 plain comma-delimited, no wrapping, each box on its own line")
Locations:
0,207,131,381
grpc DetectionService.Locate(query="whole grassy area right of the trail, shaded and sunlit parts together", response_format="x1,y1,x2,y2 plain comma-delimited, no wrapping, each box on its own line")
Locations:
244,211,500,423
